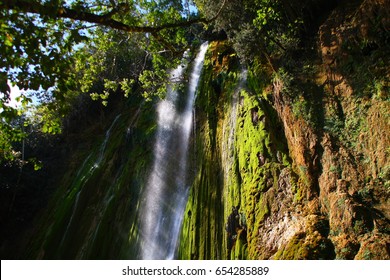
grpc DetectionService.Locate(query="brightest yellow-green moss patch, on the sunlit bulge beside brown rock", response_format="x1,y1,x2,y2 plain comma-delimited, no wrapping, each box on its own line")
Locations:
236,88,289,259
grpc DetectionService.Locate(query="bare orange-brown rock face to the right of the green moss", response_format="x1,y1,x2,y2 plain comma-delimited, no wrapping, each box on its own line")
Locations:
274,1,390,259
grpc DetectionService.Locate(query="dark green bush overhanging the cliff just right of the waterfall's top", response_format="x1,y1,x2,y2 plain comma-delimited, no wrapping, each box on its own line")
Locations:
195,0,302,63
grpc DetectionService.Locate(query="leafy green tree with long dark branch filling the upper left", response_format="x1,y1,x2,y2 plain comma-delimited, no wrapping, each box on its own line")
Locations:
0,0,225,161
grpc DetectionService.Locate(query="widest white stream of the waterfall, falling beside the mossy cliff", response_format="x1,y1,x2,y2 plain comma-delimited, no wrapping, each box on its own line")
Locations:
139,43,208,259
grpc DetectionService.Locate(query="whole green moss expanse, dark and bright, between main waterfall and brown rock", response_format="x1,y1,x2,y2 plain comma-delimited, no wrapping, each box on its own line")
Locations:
180,41,291,259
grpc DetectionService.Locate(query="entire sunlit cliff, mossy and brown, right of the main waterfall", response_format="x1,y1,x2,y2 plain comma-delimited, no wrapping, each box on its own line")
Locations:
180,1,390,259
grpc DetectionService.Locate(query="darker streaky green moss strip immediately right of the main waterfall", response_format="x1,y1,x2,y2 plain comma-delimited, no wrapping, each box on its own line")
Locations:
179,42,244,259
